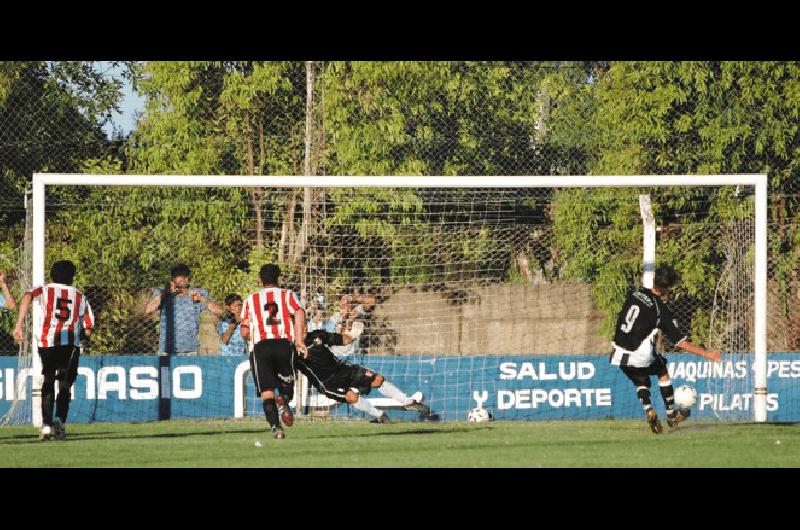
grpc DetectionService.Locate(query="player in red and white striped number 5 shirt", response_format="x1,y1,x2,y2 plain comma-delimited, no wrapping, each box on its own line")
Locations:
14,260,94,440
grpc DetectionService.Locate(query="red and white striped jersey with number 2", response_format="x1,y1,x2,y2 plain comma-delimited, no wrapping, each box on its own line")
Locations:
242,287,301,346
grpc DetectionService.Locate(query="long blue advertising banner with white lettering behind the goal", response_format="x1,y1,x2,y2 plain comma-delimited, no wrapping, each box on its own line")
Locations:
0,353,800,422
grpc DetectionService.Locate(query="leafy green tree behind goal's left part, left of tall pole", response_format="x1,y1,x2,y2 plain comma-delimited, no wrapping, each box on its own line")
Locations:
40,62,302,353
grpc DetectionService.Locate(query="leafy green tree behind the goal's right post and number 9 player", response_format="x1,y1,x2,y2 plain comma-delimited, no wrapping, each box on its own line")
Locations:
553,62,800,346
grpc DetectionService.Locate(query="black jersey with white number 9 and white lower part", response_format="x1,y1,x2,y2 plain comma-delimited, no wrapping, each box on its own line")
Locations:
611,287,688,368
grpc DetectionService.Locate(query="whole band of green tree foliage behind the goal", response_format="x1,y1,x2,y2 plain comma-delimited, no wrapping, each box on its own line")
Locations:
6,61,800,351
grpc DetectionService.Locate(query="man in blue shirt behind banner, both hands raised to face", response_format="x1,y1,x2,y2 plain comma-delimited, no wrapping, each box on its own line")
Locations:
145,263,225,355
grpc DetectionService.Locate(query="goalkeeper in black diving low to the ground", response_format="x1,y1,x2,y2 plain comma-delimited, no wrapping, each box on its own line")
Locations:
295,330,439,423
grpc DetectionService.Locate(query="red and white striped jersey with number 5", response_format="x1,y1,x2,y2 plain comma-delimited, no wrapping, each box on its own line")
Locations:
31,283,94,348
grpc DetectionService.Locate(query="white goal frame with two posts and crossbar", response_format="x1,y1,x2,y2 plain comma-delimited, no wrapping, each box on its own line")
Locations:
31,173,768,426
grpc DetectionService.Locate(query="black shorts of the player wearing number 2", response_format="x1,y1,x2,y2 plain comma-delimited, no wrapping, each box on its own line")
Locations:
250,339,294,401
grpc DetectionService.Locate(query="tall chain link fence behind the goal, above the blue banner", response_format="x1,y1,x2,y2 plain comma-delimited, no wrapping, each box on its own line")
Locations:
0,62,800,355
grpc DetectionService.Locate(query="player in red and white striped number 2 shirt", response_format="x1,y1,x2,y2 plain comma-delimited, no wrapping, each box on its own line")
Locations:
241,264,308,440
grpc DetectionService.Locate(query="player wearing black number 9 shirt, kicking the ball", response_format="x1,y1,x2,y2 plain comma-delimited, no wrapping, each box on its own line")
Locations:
610,266,720,434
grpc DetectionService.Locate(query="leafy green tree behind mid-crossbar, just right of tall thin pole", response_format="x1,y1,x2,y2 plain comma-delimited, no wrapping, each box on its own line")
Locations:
321,62,581,290
